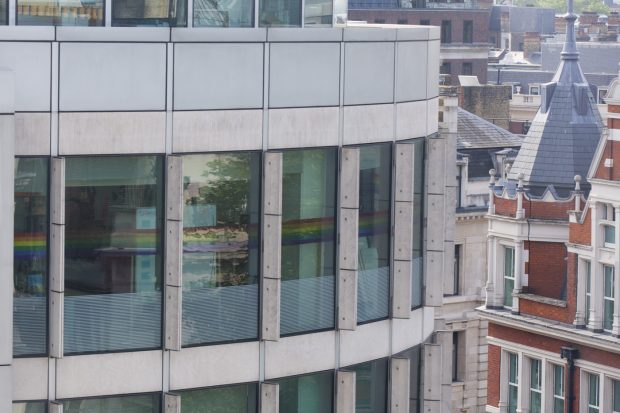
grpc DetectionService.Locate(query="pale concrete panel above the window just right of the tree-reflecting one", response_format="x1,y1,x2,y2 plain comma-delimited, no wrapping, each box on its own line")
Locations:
268,107,339,149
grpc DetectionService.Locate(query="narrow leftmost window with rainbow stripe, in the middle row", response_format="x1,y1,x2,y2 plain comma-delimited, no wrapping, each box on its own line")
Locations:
13,158,49,356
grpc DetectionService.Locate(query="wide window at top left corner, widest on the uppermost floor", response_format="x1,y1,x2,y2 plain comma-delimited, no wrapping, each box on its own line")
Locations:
16,0,104,26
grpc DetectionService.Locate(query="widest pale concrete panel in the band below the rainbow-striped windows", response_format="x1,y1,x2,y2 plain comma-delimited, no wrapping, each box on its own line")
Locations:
56,351,162,399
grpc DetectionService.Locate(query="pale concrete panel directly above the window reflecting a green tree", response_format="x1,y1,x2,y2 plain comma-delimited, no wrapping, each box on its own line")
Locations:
172,110,263,152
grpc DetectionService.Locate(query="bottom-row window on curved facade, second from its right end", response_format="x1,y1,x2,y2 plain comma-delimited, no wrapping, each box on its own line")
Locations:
347,359,388,413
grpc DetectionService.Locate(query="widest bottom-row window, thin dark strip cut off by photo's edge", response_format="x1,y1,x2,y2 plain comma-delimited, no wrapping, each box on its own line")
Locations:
62,393,161,413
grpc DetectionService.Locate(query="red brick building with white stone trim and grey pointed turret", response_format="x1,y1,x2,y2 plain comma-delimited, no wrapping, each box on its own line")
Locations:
481,2,620,413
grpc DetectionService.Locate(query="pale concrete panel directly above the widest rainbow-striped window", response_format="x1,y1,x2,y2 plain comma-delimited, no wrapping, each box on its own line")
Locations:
58,112,166,155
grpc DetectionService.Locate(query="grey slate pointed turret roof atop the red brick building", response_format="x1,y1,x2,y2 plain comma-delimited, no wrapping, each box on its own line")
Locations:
509,0,603,195
